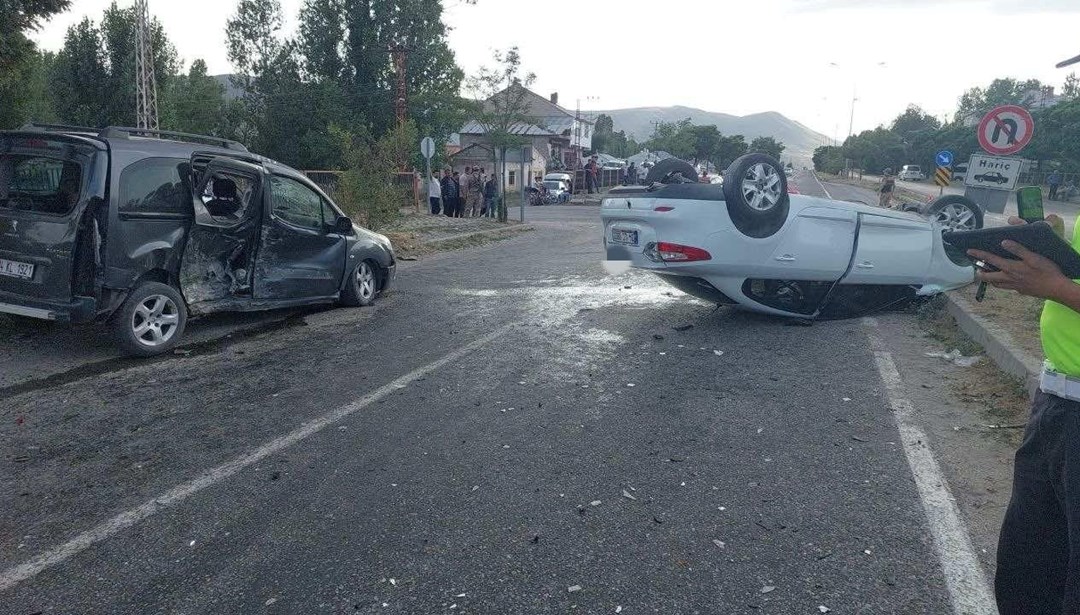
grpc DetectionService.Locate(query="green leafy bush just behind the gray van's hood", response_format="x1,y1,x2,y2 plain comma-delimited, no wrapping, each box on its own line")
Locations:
329,122,418,230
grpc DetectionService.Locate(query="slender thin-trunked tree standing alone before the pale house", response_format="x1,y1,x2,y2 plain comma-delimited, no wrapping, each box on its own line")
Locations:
469,46,536,222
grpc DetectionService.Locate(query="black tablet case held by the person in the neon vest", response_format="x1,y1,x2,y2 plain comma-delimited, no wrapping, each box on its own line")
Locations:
943,222,1080,280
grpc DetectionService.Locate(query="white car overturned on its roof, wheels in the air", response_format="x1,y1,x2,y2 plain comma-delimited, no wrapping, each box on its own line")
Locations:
602,155,974,319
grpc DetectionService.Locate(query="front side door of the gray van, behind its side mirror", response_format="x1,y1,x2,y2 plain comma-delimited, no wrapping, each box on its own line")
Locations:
255,175,348,299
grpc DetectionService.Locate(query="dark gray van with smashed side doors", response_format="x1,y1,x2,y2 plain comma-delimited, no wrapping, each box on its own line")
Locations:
0,124,396,357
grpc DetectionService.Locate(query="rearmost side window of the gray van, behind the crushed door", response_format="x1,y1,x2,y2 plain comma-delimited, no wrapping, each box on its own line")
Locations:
119,158,191,214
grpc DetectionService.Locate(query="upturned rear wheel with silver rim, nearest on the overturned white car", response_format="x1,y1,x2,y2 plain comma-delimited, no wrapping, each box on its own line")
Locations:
724,153,791,238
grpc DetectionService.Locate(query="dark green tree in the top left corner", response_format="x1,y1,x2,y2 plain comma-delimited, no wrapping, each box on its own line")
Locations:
0,0,71,129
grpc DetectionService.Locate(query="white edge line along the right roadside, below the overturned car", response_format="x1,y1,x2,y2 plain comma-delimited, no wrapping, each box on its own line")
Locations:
863,318,998,615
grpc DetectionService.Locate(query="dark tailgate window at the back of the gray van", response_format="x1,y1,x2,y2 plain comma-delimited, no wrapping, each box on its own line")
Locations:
0,137,91,216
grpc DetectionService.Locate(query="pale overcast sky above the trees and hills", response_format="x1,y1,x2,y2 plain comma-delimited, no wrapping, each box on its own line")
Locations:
27,0,1080,138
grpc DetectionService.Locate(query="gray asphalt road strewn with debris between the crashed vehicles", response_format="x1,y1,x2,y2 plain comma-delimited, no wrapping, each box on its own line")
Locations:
0,204,984,615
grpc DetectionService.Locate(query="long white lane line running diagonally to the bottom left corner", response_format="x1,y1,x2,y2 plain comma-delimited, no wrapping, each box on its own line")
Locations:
0,324,515,591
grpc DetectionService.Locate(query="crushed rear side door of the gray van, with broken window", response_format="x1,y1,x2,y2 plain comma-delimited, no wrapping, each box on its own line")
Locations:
179,157,266,313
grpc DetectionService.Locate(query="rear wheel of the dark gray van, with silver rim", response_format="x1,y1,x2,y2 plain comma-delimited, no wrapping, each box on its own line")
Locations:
112,282,188,357
